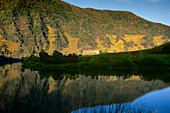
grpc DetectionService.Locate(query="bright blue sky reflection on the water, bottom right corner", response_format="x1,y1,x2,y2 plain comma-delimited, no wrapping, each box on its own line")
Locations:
72,87,170,113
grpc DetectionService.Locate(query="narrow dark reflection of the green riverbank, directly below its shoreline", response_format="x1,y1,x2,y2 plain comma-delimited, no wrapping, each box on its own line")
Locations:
39,65,170,83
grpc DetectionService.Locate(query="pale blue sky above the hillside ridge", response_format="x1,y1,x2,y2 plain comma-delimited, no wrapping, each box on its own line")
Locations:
63,0,170,26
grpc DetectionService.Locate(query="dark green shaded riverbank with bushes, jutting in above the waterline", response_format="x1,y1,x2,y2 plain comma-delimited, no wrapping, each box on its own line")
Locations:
23,43,170,70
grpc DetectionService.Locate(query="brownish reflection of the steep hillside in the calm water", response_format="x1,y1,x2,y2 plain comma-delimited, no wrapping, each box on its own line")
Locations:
0,64,167,113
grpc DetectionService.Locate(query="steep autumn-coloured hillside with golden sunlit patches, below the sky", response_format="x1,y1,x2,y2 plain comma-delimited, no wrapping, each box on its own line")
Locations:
0,0,170,57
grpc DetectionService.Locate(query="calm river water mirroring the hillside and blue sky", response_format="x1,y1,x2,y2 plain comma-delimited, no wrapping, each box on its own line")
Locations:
0,63,170,113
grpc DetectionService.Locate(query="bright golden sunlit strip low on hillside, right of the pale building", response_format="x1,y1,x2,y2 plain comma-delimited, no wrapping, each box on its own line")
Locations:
97,34,170,52
